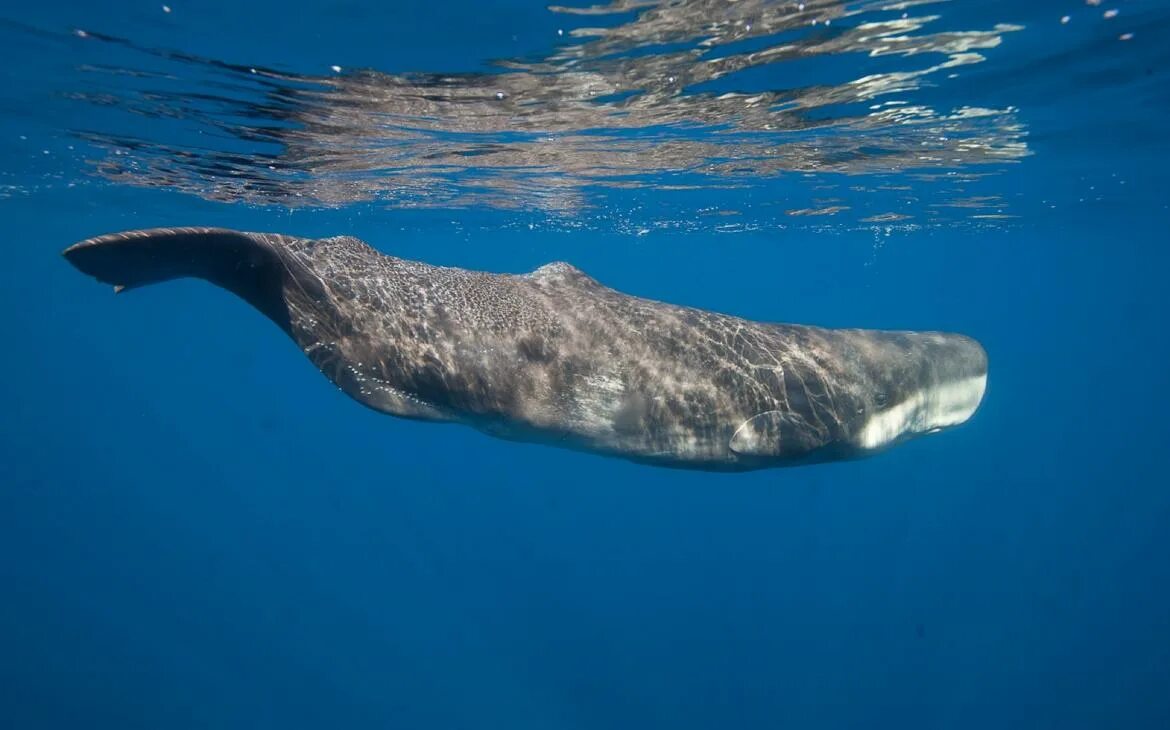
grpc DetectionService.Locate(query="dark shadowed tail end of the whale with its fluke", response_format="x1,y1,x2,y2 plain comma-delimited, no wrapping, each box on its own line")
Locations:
64,228,299,331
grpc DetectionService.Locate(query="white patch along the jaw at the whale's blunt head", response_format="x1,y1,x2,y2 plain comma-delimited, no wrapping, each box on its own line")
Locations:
856,374,987,449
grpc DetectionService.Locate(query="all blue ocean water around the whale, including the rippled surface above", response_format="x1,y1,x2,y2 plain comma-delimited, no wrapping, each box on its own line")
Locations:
0,0,1170,730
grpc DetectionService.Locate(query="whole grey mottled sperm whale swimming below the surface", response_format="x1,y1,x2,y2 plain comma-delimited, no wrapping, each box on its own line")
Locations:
64,228,987,470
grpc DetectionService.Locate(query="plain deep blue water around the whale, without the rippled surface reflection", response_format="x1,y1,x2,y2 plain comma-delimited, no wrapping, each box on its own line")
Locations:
0,0,1170,730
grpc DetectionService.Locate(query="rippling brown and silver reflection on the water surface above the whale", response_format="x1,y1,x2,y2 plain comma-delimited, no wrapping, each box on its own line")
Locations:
54,0,1028,226
